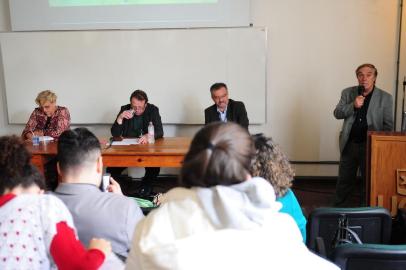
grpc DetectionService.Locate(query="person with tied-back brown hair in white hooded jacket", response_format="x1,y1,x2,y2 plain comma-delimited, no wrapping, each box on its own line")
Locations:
126,123,338,270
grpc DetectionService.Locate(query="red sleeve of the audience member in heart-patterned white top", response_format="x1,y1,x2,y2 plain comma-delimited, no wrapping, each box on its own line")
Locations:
50,221,105,270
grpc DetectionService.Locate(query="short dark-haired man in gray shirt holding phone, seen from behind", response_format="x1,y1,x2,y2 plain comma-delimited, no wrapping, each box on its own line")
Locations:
54,128,144,257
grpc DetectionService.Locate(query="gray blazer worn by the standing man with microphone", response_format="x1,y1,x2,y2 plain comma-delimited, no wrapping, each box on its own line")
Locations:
334,86,393,153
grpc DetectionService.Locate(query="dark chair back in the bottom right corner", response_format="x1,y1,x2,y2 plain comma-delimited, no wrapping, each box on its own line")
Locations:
332,244,406,270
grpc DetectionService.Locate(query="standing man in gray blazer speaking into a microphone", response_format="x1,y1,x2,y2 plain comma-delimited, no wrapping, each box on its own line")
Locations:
334,64,393,207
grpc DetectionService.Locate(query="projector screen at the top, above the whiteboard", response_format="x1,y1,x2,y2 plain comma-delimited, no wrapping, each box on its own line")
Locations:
10,0,250,31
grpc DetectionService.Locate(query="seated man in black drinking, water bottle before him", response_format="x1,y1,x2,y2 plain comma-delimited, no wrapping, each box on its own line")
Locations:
107,90,164,197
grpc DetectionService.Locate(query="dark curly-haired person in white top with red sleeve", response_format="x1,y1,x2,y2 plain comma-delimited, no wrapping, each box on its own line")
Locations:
0,136,111,269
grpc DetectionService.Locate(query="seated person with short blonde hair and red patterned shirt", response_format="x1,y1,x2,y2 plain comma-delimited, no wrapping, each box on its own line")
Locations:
21,90,70,140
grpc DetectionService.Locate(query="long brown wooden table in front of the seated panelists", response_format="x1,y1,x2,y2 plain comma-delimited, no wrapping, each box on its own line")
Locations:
27,137,191,172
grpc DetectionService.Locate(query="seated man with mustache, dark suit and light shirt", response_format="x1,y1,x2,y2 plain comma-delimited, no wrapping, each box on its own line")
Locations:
204,83,249,129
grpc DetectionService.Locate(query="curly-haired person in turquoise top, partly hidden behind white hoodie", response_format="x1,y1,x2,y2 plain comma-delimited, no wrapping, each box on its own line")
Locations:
251,134,306,242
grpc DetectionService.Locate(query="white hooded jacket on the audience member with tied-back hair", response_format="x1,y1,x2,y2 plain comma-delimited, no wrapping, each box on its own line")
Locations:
126,178,338,270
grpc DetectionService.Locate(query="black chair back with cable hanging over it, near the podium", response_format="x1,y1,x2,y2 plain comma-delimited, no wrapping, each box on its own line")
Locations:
307,207,392,257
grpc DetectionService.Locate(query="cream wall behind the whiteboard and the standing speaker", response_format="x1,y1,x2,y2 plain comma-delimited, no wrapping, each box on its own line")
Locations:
0,0,406,175
